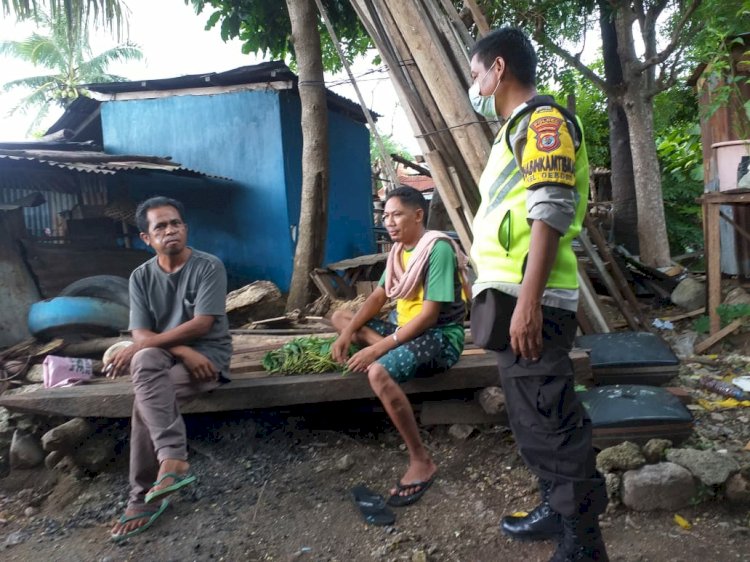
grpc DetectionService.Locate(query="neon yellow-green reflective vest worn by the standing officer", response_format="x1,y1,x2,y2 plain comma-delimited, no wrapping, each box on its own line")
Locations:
471,102,589,289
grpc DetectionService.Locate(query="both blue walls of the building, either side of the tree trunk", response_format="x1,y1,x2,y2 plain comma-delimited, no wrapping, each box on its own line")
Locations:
102,91,375,291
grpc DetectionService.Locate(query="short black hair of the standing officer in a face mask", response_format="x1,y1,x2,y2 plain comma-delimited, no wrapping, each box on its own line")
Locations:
469,27,537,86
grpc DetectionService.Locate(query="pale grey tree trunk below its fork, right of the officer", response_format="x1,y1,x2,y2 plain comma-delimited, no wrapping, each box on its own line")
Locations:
625,88,671,267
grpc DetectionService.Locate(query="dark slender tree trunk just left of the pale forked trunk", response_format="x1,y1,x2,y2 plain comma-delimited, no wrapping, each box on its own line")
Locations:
599,0,640,254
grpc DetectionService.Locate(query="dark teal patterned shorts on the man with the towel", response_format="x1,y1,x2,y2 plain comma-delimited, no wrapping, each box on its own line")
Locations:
366,320,461,383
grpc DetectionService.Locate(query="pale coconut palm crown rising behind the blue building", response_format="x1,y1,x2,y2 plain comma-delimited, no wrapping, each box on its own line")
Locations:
0,8,143,128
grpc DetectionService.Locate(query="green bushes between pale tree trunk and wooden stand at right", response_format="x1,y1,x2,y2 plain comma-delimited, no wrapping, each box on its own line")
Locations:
656,125,703,254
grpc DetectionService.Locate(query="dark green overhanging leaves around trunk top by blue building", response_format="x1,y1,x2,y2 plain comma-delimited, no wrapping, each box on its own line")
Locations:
185,0,372,72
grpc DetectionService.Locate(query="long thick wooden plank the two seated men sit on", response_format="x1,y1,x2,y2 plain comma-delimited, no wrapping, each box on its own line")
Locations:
0,354,506,418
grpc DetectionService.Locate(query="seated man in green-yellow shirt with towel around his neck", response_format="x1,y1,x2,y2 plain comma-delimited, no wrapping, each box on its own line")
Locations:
332,187,468,507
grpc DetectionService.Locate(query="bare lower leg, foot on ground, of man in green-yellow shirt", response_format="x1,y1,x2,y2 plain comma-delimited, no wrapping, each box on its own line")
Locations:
367,363,437,496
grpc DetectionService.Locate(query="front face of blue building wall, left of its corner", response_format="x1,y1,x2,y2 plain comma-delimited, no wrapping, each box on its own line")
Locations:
102,92,292,290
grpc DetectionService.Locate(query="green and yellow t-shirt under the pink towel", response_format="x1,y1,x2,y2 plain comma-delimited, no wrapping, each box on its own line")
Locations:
379,240,466,353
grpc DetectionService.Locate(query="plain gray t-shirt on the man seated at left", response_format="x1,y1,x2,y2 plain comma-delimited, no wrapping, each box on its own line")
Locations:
130,248,232,377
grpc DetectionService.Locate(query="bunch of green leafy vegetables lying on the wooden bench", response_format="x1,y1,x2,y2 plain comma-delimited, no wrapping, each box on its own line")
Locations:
263,336,358,375
